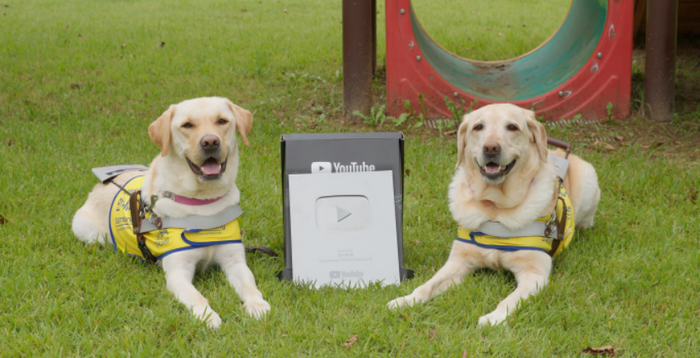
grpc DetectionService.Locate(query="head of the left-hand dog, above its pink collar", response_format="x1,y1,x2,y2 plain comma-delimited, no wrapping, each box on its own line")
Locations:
148,97,253,181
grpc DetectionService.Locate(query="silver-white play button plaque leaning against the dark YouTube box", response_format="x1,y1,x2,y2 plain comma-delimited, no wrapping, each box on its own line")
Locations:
289,171,401,288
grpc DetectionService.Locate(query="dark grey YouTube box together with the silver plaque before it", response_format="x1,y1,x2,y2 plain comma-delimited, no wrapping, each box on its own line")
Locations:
277,132,413,287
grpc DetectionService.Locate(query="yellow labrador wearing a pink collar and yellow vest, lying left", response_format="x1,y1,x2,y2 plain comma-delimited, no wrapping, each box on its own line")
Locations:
73,97,270,328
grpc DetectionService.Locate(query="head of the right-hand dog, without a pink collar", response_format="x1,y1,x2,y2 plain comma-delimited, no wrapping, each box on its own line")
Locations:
457,104,547,184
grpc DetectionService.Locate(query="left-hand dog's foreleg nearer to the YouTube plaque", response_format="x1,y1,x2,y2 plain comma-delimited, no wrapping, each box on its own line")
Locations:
215,244,270,319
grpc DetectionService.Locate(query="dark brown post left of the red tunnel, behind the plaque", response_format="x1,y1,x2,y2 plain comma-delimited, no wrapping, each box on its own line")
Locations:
343,0,376,120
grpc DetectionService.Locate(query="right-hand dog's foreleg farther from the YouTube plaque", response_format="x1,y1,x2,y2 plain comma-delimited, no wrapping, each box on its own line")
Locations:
479,251,552,326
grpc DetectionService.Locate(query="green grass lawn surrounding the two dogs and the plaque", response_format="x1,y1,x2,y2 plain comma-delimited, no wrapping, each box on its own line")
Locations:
0,0,700,357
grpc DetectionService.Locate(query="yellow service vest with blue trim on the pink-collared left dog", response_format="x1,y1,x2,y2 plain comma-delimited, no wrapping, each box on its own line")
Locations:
109,176,241,260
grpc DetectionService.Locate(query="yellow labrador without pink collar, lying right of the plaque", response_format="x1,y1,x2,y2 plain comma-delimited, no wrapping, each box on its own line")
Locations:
388,104,600,325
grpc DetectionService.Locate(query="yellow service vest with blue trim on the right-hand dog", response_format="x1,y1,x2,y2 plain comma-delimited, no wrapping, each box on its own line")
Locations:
457,183,575,256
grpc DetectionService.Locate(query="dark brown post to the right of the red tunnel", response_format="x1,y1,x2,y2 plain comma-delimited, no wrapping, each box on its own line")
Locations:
644,0,678,122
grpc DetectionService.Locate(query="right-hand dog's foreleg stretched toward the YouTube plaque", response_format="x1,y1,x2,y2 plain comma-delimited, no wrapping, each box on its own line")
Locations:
388,241,478,309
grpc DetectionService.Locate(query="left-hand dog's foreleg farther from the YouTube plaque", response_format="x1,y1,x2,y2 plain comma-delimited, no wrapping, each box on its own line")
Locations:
163,249,221,329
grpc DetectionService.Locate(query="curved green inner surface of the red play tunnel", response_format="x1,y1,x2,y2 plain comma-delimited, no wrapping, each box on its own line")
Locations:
410,0,608,101
